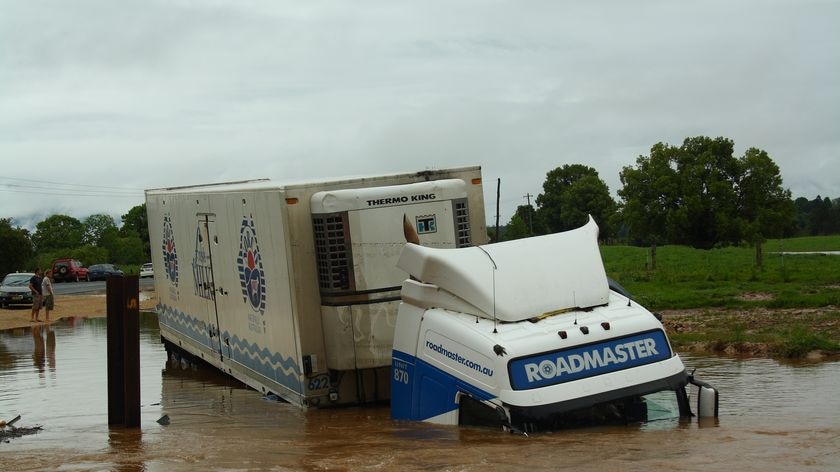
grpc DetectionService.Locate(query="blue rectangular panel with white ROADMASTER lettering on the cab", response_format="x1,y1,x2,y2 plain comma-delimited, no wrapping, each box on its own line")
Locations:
509,331,671,390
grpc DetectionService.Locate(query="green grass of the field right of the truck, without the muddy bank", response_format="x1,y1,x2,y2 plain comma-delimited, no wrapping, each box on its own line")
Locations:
601,236,840,310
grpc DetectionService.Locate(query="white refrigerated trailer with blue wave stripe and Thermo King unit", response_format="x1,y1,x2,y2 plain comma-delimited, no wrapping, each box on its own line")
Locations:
146,167,487,406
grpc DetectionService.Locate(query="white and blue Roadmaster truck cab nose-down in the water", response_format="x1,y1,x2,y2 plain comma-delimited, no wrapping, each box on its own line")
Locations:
391,217,718,433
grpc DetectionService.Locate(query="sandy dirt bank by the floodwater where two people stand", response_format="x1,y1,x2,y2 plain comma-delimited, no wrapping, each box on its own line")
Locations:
0,291,157,330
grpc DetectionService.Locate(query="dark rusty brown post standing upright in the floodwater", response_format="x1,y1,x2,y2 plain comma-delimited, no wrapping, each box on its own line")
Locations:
106,275,140,428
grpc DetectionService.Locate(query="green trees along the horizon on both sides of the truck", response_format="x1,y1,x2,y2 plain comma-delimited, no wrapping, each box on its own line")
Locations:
0,136,840,275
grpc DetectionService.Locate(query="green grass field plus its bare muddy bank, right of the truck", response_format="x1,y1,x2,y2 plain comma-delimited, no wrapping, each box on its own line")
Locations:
601,236,840,357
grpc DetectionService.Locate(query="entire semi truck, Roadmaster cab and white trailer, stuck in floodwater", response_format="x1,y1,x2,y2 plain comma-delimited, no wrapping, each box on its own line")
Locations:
146,167,718,432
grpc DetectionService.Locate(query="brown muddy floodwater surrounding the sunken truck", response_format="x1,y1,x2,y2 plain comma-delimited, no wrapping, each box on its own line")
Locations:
0,314,840,472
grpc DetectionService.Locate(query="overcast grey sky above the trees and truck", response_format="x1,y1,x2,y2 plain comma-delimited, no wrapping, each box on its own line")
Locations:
0,0,840,230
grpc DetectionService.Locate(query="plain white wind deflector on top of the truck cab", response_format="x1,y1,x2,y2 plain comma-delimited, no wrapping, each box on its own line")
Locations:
398,217,609,322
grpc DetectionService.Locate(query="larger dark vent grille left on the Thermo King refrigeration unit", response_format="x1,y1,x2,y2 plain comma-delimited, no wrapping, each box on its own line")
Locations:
312,212,355,291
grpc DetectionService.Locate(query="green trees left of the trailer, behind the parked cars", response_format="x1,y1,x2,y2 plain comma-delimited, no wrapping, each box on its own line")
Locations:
0,203,151,275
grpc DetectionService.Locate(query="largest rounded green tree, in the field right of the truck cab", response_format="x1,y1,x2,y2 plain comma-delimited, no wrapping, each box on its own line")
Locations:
618,136,794,249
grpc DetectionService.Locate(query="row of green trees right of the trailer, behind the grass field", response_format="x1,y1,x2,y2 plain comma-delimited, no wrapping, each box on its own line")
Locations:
498,136,840,249
